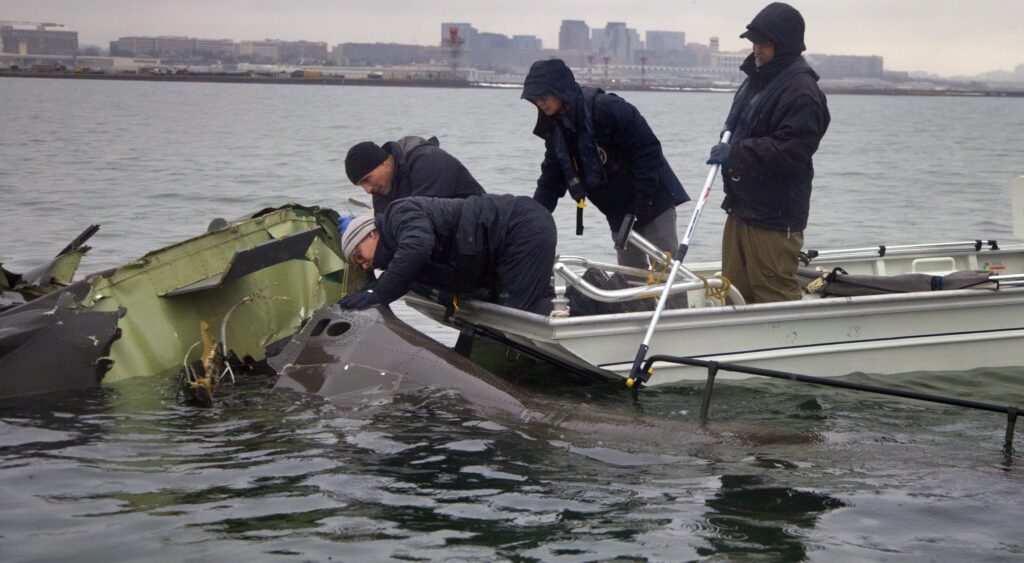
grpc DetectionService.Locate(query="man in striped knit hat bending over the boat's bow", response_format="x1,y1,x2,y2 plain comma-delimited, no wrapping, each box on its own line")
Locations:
339,194,556,315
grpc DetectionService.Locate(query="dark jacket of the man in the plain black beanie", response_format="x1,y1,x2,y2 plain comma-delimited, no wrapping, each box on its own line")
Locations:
374,136,484,212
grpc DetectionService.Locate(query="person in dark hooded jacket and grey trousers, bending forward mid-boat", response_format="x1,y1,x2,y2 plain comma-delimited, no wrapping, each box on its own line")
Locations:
522,58,689,268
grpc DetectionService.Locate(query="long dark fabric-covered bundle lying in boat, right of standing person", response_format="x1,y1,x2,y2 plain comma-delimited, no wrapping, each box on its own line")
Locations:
797,267,998,297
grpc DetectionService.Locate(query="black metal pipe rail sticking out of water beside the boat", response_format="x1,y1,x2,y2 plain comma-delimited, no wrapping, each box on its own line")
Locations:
634,355,1021,459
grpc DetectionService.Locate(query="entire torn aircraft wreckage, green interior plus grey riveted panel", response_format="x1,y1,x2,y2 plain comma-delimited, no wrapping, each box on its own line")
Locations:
0,205,598,422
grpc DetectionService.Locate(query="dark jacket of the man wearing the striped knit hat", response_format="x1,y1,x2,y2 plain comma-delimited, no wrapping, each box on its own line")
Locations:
374,194,524,303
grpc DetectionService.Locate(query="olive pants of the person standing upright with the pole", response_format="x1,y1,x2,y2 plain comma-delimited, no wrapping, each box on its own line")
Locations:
722,215,804,303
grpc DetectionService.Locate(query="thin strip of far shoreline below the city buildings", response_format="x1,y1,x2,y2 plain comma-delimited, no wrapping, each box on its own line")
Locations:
0,71,1024,98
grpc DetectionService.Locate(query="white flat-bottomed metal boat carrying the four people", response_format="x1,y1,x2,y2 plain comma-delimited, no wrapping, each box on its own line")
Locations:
407,178,1024,385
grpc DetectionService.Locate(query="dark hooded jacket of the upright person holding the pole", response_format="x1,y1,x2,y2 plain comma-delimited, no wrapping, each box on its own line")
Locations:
722,3,830,232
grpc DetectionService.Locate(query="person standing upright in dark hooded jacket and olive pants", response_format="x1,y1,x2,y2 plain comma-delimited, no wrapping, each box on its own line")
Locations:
708,2,830,303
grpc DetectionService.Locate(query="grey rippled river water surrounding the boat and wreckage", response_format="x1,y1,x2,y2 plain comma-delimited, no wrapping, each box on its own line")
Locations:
0,78,1024,561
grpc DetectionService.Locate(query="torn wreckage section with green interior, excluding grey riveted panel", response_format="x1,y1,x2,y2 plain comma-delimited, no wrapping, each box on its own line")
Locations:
0,205,356,400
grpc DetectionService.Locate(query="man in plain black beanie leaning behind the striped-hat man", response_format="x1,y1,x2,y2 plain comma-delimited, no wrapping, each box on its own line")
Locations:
345,136,484,211
